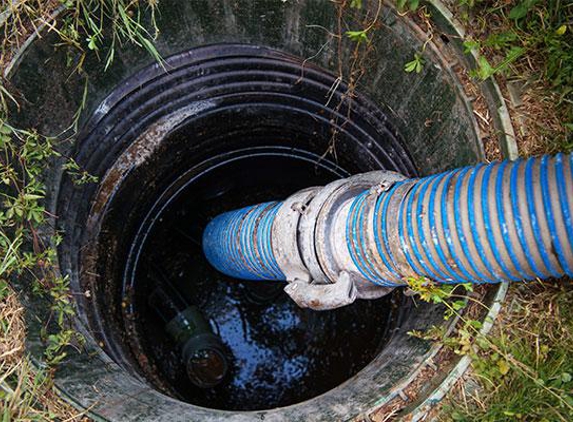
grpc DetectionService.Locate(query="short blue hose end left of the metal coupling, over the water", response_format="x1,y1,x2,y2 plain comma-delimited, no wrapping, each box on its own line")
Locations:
203,202,285,280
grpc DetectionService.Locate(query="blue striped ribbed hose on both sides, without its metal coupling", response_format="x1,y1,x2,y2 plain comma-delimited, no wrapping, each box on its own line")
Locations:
204,154,573,286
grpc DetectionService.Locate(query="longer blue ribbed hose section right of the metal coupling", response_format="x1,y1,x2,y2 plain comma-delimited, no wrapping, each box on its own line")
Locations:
346,154,573,286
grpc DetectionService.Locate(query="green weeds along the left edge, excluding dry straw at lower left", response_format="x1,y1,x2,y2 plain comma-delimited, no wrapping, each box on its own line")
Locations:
0,0,161,364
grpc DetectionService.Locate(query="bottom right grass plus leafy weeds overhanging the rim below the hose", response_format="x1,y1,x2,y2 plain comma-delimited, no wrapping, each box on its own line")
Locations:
409,278,573,422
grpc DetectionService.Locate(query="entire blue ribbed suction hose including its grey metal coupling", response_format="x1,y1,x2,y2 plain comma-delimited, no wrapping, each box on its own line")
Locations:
203,154,573,309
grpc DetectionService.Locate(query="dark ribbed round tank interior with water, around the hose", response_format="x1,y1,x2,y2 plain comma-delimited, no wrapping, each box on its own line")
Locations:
68,45,416,410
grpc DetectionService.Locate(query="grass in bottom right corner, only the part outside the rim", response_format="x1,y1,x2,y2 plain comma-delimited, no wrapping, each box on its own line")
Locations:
440,280,573,422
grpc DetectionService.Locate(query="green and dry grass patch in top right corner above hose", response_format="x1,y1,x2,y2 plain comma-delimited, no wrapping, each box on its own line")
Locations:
457,0,573,155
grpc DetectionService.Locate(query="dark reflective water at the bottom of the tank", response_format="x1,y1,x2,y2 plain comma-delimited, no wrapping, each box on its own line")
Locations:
129,155,398,410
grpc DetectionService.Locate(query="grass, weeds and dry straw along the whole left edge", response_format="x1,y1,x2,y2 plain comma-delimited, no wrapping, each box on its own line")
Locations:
0,0,161,422
